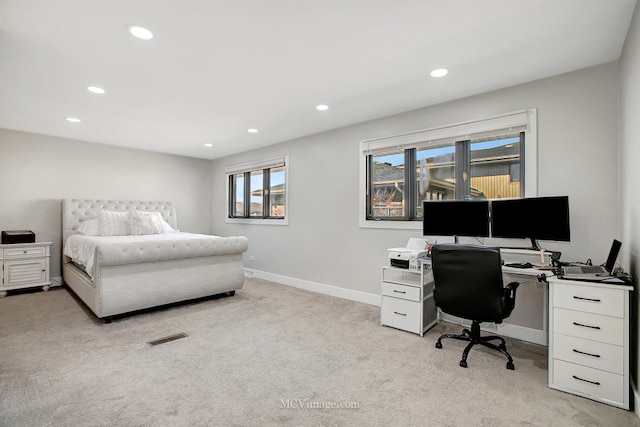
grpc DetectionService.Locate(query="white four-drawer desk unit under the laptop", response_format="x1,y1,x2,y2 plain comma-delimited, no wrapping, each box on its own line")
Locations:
547,278,633,409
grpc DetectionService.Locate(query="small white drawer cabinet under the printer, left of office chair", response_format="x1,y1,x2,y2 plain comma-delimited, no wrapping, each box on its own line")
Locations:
380,262,438,336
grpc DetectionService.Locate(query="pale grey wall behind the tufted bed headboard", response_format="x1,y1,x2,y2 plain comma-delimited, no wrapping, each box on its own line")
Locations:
0,129,211,277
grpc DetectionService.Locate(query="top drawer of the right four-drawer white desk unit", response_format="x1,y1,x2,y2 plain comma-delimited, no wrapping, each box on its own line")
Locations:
553,283,626,317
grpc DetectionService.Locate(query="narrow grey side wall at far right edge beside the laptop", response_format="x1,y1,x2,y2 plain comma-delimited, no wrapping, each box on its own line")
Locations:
620,0,640,402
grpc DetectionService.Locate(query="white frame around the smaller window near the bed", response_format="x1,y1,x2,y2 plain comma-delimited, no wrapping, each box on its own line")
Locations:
224,156,290,225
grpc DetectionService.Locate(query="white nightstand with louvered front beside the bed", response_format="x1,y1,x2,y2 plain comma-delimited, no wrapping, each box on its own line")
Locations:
0,242,52,297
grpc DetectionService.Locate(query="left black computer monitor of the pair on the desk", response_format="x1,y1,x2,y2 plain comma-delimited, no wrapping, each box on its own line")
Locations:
422,199,489,242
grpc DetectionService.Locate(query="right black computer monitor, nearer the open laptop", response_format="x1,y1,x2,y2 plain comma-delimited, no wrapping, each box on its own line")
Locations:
491,196,571,250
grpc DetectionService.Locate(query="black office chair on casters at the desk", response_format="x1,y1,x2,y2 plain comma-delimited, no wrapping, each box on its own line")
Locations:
431,244,519,370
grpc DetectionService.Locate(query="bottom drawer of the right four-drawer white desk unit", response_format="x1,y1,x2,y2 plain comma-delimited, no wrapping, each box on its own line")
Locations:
553,360,628,403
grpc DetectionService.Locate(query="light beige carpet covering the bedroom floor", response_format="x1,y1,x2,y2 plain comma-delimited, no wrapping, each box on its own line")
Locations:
0,279,640,427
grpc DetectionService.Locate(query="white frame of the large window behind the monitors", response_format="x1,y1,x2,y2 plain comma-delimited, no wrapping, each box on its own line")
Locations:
358,108,538,230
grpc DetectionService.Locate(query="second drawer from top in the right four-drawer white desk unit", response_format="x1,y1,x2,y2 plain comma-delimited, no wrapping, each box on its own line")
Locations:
553,308,625,346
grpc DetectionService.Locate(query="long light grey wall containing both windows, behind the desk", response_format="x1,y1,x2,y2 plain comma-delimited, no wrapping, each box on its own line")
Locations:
211,63,618,332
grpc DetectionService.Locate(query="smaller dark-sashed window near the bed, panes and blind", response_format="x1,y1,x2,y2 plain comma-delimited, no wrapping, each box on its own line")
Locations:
226,157,288,225
